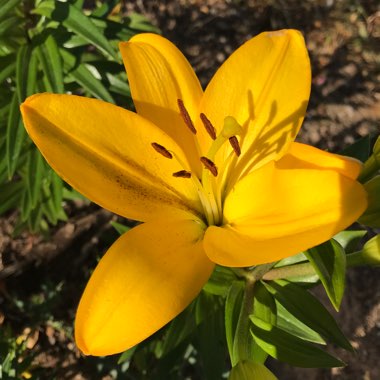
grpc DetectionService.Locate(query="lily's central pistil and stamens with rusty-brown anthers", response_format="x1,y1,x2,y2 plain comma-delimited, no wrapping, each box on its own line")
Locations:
152,99,243,225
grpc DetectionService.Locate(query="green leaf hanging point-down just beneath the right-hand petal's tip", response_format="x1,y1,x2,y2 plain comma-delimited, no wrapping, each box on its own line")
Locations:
305,239,346,311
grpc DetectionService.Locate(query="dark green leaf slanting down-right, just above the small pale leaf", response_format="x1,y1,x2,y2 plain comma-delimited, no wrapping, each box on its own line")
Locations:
265,280,352,351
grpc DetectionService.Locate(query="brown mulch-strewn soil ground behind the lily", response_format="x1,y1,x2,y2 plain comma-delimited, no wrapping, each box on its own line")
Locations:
0,0,380,380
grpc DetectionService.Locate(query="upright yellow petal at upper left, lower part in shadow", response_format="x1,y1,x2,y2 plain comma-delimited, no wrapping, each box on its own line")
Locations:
119,33,203,169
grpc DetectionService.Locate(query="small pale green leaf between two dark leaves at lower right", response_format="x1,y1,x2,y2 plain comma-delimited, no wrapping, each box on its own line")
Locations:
276,302,326,344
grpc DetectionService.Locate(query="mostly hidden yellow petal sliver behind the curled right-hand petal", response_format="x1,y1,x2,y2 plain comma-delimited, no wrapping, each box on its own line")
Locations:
277,142,363,179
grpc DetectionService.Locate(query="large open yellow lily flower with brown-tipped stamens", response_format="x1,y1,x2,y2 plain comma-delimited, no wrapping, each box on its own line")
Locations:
22,30,367,355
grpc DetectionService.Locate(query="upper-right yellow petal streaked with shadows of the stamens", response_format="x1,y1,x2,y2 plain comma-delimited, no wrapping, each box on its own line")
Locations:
201,30,311,180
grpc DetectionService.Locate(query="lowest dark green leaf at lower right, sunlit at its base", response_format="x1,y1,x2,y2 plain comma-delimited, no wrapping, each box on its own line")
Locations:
251,316,344,368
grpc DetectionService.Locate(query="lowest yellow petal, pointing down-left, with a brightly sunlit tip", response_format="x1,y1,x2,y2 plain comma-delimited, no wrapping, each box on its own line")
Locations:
75,220,214,356
